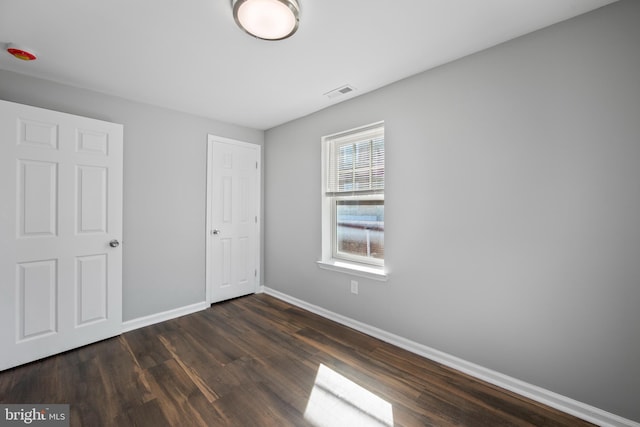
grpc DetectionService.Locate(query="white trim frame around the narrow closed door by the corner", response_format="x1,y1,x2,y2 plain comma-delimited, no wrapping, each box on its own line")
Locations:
205,134,262,304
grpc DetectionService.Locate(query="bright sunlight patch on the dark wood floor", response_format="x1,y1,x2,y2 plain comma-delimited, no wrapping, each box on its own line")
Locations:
304,364,393,427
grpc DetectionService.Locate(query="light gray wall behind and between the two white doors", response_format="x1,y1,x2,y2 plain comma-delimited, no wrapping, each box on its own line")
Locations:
0,70,264,320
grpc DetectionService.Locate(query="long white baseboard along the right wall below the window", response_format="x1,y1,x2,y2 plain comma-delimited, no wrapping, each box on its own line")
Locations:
263,287,640,427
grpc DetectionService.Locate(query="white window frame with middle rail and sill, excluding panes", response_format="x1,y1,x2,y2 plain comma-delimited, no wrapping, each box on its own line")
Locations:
318,121,387,280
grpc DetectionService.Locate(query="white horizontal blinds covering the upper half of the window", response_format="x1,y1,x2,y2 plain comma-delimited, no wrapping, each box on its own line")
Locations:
326,123,384,195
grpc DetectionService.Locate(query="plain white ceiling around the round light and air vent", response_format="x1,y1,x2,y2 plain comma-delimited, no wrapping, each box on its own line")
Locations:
0,0,615,129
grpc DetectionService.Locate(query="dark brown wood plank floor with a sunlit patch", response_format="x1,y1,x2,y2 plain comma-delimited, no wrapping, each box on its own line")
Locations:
0,294,590,427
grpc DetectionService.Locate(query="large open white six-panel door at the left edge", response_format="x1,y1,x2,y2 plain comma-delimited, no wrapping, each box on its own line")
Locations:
0,101,123,370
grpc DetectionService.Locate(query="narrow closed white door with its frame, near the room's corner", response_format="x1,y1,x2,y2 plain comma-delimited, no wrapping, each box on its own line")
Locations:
207,135,260,303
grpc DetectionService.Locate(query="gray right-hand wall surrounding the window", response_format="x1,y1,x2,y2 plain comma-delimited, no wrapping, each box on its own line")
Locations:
265,0,640,421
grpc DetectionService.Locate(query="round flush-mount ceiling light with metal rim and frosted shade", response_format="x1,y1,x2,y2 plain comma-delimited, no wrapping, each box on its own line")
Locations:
232,0,300,40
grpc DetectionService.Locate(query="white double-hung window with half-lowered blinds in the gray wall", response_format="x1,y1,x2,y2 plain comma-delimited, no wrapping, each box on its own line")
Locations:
322,123,384,280
